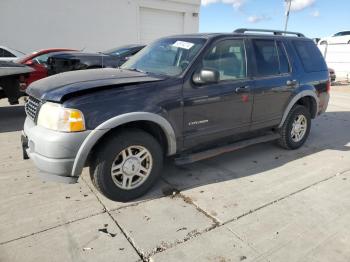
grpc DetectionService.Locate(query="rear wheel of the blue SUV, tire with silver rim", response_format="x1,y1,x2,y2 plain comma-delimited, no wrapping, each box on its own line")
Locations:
278,105,311,150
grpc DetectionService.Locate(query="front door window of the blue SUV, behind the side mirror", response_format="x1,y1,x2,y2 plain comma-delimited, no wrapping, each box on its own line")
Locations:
203,40,247,81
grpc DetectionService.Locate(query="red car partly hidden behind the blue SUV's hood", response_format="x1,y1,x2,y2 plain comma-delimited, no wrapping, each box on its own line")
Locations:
15,48,77,91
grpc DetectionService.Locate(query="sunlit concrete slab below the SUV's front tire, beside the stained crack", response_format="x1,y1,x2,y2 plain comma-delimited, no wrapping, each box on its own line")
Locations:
111,197,214,257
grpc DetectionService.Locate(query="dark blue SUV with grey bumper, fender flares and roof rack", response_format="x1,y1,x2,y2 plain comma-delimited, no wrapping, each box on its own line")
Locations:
22,29,330,201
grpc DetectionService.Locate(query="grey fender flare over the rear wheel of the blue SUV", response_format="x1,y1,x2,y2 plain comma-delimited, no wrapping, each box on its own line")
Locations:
278,90,319,128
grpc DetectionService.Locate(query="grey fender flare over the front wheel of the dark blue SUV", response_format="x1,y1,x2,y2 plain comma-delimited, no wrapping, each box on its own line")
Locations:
72,112,177,176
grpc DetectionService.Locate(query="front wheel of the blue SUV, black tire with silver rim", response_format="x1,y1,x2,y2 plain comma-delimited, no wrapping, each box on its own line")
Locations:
90,129,164,202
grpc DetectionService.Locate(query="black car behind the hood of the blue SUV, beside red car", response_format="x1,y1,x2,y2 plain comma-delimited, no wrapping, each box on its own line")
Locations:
48,45,145,75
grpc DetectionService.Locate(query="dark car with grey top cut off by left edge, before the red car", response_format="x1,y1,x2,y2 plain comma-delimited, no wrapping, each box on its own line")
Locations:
0,61,33,105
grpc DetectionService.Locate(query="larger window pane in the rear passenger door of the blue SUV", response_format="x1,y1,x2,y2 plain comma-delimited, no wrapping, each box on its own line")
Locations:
253,40,280,76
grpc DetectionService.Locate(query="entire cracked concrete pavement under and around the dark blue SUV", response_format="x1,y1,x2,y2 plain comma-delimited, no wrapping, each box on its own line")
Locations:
0,87,350,261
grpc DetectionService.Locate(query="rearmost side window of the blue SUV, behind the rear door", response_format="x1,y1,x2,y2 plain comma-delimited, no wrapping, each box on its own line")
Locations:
293,41,327,72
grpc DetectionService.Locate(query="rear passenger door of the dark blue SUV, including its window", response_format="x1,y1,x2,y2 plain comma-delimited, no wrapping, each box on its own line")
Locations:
251,39,298,130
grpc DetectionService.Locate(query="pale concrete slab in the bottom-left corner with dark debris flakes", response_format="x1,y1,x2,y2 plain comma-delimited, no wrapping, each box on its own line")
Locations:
0,214,139,262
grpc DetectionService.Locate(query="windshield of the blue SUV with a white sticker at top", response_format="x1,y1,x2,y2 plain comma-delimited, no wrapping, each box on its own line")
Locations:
121,38,206,76
